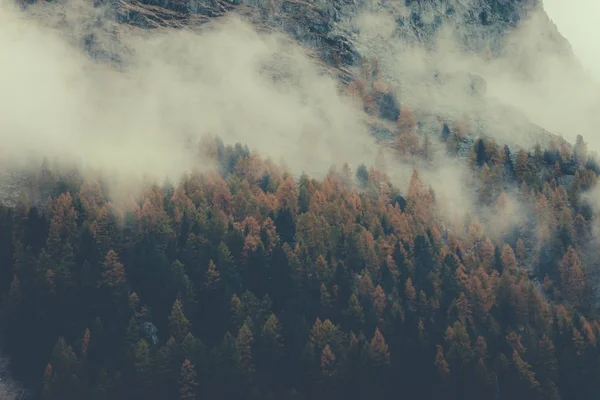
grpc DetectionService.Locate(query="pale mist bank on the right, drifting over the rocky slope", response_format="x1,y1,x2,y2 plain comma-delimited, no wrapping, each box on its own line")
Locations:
353,4,600,153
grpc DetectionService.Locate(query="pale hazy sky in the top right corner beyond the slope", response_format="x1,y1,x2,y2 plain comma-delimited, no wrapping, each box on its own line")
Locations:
544,0,600,79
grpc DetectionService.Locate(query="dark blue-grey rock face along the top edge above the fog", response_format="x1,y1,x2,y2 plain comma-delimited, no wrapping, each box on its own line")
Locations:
102,0,570,72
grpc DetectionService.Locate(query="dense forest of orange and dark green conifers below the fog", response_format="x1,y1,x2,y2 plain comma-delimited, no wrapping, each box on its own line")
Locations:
0,119,600,400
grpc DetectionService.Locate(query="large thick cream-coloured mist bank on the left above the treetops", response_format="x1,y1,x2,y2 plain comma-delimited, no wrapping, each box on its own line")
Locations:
0,0,373,186
